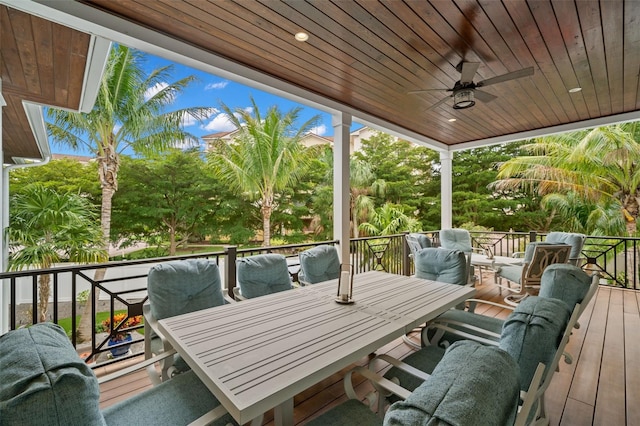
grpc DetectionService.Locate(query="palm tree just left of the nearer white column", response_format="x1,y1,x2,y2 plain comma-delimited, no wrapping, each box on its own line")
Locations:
209,98,319,243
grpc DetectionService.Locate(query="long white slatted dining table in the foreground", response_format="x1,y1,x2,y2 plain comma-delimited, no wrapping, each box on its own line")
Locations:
159,271,475,425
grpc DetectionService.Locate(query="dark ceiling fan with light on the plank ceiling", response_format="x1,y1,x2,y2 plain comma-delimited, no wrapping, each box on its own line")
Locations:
407,61,533,109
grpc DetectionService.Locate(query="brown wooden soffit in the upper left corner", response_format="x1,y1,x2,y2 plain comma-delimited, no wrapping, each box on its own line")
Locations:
0,6,90,163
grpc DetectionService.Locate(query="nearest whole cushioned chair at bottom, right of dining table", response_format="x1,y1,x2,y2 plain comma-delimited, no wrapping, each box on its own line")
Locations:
307,341,542,426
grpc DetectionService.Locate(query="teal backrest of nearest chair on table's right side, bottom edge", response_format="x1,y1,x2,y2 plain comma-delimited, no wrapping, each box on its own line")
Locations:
384,341,520,426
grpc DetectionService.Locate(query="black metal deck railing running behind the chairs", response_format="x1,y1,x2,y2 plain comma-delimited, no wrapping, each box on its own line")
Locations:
0,231,640,366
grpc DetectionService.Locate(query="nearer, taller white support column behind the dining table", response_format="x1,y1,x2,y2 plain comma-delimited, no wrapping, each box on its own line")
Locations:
331,112,351,271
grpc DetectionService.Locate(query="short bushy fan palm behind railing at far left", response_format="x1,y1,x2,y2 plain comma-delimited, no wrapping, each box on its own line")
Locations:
9,184,108,322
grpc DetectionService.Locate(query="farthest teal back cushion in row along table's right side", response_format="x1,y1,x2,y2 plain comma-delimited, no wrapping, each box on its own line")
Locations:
539,263,591,310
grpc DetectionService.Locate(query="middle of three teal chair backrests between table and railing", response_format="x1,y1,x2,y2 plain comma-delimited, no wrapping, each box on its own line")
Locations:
236,253,293,298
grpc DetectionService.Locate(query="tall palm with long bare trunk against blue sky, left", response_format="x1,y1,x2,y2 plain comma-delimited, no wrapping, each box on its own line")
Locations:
48,45,211,340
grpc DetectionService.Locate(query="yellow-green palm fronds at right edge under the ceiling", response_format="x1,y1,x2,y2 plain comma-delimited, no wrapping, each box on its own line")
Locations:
492,123,640,235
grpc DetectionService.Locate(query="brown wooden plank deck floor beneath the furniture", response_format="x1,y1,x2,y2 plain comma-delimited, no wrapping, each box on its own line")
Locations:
96,279,640,426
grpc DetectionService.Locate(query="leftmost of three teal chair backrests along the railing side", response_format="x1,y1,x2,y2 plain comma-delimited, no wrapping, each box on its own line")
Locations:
147,259,225,320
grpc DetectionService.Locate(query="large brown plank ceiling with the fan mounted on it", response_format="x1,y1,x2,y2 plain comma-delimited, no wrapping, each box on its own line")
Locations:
80,0,640,146
